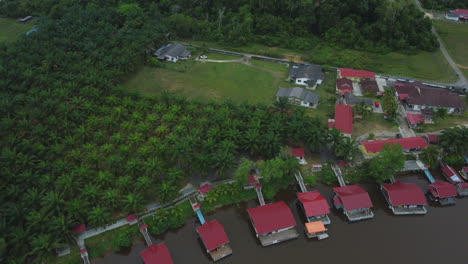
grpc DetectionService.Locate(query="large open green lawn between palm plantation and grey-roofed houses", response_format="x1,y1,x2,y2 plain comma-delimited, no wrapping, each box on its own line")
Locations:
124,61,286,104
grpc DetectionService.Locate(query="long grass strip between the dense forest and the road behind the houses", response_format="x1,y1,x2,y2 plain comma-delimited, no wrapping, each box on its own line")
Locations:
179,38,458,83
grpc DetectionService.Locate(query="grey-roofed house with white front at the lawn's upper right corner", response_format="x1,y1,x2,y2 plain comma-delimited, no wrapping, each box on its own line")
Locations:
289,65,325,89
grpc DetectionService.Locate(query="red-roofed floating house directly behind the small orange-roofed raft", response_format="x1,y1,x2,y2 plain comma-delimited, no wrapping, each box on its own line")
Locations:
297,191,331,225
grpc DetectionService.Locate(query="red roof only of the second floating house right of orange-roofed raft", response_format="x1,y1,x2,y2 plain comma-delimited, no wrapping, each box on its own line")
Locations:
382,181,427,206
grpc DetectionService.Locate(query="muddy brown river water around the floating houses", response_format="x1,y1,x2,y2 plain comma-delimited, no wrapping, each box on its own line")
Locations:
92,174,468,264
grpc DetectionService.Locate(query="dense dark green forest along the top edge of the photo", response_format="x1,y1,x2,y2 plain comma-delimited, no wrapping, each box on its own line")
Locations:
0,0,438,52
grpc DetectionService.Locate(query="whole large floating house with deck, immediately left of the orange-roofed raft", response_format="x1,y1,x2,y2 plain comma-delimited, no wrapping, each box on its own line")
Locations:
247,201,299,246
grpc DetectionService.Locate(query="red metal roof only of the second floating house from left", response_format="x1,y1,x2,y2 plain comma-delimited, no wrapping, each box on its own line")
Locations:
197,220,229,251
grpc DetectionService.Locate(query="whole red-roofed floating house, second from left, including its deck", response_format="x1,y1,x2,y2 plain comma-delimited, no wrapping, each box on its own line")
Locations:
197,220,232,261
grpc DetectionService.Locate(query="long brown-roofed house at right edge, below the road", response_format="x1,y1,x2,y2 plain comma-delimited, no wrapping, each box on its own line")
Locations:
394,82,465,114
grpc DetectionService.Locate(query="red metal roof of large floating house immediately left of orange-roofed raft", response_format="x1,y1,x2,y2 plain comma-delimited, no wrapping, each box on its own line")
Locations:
247,201,296,235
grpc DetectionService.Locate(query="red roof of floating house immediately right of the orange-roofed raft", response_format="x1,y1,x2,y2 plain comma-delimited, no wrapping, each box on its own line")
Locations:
333,184,373,210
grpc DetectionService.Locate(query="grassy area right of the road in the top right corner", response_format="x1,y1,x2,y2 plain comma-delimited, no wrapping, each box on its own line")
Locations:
434,20,468,68
